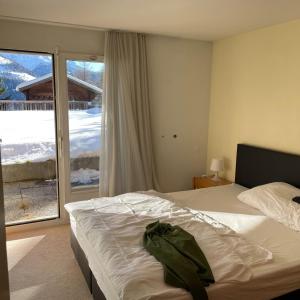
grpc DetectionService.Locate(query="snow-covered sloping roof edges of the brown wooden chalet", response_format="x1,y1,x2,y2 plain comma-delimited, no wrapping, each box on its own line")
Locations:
16,73,103,94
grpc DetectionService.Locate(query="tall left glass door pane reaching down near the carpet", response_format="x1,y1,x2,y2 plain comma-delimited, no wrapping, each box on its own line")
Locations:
0,51,59,225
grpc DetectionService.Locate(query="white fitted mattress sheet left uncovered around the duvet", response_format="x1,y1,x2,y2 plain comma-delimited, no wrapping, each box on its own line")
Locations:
71,184,300,300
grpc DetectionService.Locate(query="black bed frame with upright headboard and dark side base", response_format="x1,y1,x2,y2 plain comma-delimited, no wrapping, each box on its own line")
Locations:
71,144,300,300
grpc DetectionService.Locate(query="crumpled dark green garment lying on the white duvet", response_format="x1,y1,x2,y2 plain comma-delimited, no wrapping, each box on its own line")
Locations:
143,221,215,300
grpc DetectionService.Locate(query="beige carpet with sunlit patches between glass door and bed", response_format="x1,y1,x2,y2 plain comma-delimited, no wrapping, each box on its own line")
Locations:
7,225,92,300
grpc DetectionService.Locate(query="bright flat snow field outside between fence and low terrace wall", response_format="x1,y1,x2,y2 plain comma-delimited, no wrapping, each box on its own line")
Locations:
0,108,101,164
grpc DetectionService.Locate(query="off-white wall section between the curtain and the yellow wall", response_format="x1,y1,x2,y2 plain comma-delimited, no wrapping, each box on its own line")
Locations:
147,36,211,192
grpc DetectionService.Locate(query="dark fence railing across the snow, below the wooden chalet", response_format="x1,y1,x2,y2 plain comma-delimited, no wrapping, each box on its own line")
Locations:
0,100,91,111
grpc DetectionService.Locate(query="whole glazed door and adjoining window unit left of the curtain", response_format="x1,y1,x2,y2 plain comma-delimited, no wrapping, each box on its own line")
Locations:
0,50,104,225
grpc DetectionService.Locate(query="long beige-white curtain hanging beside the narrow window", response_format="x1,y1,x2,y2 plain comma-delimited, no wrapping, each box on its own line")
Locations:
100,31,157,196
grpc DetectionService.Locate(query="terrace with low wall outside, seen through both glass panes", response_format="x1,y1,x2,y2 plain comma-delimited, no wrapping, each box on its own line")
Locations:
2,156,99,225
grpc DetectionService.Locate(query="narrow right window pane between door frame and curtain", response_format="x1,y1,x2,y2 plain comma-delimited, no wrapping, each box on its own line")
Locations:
67,60,104,188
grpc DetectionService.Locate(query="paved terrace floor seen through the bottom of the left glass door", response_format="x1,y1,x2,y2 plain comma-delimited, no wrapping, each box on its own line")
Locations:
4,180,58,224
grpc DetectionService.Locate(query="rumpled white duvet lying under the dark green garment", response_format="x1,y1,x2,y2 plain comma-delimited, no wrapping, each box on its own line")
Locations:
65,193,272,300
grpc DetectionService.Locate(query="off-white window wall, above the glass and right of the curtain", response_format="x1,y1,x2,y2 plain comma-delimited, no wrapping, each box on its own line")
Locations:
0,20,211,191
